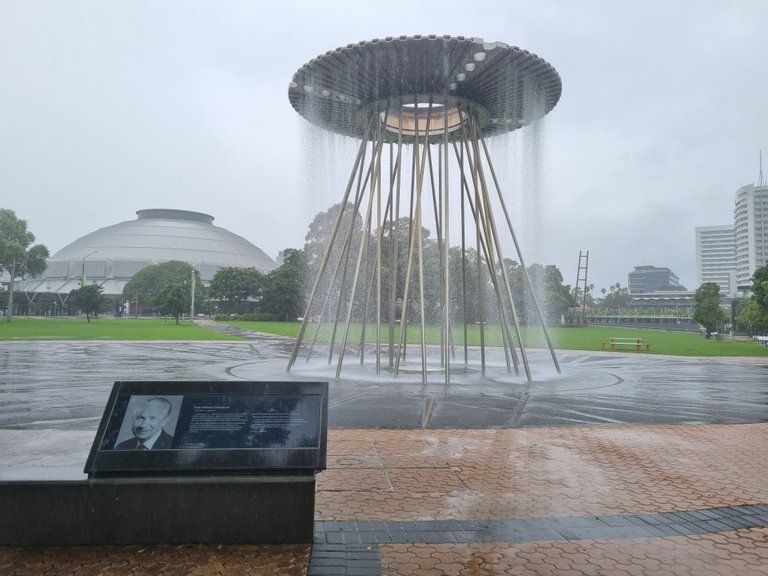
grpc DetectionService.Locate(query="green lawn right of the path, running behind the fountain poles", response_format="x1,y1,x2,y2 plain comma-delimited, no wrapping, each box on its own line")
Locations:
230,321,768,356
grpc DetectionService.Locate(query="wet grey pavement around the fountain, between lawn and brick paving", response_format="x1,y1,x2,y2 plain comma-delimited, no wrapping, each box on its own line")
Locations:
0,336,768,431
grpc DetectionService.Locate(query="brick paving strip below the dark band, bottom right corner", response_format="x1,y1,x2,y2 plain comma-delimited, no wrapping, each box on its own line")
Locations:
380,528,768,576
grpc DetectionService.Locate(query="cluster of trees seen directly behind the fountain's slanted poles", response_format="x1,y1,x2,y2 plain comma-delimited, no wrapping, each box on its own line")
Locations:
292,203,575,324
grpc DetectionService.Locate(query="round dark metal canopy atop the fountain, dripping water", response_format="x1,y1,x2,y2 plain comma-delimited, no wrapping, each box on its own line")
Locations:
288,36,562,141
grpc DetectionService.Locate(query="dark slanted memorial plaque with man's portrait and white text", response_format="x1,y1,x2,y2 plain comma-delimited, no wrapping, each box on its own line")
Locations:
85,381,328,477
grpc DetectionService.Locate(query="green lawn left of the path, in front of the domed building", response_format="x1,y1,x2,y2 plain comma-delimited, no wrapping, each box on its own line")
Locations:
0,316,239,340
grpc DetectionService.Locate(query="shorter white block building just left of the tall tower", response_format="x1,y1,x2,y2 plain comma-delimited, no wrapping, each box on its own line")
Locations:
696,224,736,297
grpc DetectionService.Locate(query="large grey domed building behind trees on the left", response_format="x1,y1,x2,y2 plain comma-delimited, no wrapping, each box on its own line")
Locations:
17,209,276,306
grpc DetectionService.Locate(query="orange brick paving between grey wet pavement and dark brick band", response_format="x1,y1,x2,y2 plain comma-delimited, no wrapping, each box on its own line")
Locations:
316,424,768,520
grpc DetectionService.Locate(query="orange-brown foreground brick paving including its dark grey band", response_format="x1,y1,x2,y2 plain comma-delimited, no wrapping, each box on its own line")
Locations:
0,424,768,576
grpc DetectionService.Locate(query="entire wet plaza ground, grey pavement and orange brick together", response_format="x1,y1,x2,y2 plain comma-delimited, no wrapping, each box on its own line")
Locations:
0,337,768,575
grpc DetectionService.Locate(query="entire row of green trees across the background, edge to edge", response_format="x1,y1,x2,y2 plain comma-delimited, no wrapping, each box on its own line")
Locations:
7,204,768,335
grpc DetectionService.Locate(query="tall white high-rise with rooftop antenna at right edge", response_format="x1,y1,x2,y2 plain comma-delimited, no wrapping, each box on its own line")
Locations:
733,183,768,291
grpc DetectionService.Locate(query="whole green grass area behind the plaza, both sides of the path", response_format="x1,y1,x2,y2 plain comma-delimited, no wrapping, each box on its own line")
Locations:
0,317,768,357
